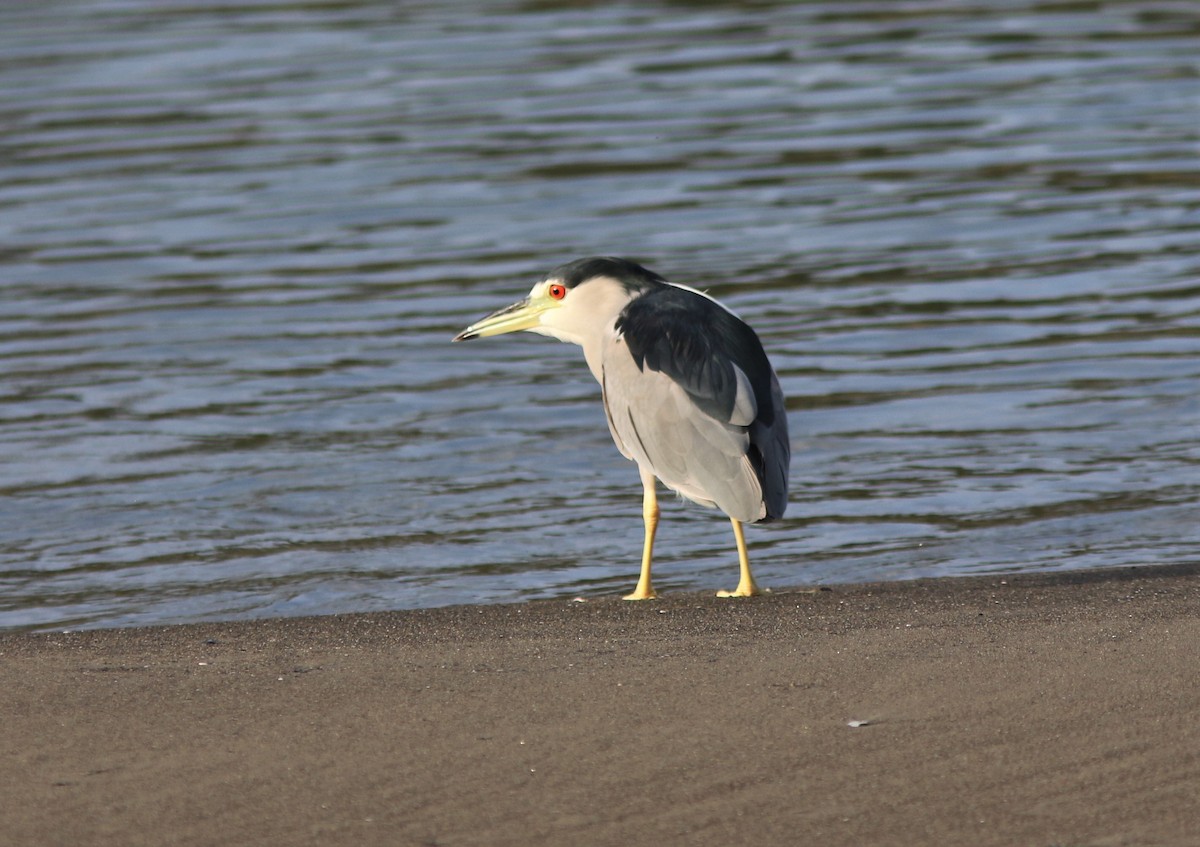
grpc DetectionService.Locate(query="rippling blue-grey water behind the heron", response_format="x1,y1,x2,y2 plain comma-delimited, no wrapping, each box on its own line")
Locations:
0,0,1200,629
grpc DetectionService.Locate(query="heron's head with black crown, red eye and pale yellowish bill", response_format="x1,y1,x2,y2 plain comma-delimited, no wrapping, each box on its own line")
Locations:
454,257,665,346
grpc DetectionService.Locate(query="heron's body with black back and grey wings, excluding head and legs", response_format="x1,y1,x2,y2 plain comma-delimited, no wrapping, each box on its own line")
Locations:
601,288,791,522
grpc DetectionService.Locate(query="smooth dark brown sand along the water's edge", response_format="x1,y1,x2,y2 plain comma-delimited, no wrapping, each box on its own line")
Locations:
0,565,1200,847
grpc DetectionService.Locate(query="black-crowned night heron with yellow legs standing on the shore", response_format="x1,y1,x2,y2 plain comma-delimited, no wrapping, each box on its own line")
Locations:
452,256,791,600
